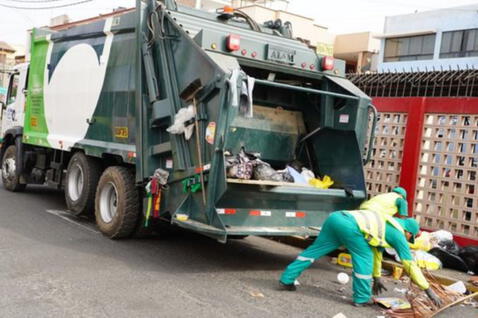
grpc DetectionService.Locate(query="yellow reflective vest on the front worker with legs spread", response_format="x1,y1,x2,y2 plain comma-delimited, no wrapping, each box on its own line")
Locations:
348,210,405,247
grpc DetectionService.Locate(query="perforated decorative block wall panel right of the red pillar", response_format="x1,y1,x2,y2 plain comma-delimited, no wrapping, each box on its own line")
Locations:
415,113,478,238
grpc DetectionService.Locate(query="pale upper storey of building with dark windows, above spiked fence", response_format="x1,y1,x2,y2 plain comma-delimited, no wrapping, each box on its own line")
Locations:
378,4,478,72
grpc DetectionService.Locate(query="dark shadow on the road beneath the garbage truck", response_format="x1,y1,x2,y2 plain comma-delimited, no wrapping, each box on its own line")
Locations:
0,186,322,273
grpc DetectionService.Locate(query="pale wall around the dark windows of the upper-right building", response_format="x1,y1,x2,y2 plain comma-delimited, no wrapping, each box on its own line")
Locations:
378,4,478,72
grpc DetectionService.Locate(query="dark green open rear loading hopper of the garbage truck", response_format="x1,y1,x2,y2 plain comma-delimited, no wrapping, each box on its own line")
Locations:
137,2,373,241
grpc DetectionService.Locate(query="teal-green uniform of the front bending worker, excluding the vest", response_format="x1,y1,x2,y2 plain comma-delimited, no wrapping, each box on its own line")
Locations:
280,211,429,303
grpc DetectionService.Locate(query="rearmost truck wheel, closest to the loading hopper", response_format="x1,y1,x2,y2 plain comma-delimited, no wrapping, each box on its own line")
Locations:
95,166,139,239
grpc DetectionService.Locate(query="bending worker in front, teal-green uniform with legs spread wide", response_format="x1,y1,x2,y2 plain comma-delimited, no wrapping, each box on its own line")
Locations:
280,210,441,306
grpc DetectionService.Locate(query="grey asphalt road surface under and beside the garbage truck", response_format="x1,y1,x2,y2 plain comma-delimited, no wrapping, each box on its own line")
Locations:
0,185,476,318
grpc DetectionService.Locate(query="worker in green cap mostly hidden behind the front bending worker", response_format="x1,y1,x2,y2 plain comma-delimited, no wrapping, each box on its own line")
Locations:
359,187,408,217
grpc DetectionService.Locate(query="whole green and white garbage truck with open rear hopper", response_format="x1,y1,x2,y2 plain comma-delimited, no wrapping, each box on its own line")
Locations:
0,0,376,242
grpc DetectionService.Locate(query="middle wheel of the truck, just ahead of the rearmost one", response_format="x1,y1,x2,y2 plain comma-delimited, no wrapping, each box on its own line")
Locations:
65,152,101,216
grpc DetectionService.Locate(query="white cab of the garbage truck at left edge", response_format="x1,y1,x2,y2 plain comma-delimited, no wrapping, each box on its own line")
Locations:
0,63,28,140
